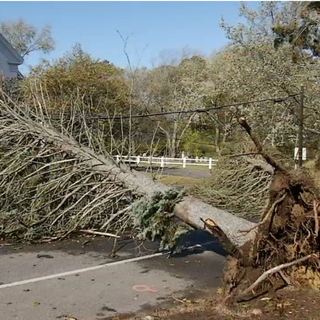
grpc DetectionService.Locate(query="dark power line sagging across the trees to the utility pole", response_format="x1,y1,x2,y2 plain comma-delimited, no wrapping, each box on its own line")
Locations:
86,93,300,120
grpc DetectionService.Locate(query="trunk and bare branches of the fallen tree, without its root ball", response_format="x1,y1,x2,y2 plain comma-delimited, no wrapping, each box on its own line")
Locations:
0,94,255,246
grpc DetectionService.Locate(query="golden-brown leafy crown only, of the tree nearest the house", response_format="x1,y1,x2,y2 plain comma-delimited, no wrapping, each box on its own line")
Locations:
28,44,128,116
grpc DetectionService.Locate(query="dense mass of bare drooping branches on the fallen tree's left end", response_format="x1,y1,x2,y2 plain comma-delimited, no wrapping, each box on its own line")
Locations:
0,91,136,242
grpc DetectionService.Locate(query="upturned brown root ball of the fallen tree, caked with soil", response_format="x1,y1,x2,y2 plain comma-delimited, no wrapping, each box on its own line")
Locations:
224,171,320,301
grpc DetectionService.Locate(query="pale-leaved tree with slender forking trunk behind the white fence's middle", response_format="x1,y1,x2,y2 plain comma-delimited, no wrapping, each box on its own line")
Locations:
134,56,207,157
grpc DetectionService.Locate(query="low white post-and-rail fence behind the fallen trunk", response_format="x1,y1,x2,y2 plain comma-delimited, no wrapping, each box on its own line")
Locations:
114,155,218,169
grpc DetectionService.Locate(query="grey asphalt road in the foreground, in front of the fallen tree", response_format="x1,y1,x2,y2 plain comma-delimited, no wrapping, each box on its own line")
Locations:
0,231,225,320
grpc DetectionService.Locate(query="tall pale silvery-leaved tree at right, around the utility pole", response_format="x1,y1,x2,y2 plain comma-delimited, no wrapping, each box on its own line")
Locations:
211,2,319,153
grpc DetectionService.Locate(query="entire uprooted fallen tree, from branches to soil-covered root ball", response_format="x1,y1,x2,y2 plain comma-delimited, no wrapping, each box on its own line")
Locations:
0,94,319,301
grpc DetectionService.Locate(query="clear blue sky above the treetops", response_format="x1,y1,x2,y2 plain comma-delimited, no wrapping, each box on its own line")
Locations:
0,1,257,69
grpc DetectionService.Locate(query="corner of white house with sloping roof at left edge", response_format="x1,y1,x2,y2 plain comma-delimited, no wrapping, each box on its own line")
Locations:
0,33,23,78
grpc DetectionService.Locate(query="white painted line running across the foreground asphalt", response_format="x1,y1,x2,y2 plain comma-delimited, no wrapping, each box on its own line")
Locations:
0,241,215,289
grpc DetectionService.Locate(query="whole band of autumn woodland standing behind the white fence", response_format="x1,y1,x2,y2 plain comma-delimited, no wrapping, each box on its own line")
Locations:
7,2,319,159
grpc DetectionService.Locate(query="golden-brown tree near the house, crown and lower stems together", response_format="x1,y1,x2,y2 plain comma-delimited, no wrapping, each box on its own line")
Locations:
21,44,133,154
